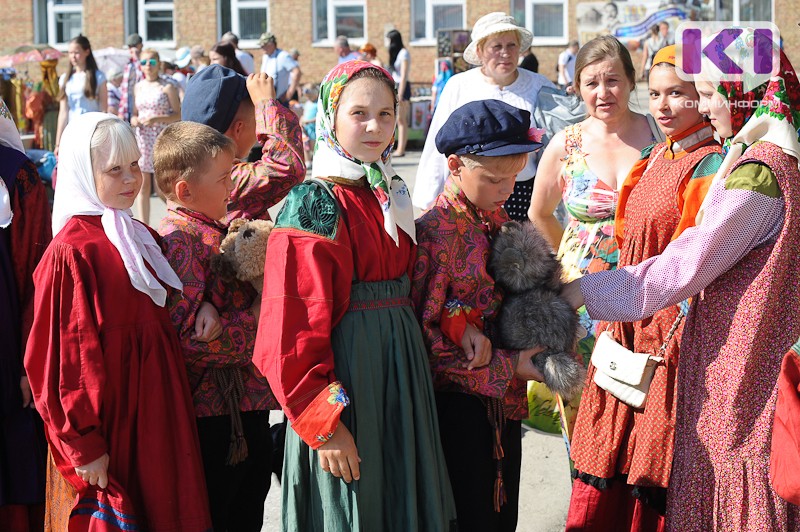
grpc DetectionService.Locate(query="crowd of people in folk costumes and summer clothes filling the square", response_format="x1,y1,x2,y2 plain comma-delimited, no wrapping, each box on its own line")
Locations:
0,7,800,532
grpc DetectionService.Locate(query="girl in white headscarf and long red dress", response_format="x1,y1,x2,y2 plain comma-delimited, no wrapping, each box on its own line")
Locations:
25,113,211,531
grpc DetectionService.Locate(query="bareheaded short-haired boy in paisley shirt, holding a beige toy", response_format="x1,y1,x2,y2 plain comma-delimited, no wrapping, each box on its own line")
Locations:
154,117,277,530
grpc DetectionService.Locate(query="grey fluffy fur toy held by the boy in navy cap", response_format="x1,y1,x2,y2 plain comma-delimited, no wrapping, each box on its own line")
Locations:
489,222,586,399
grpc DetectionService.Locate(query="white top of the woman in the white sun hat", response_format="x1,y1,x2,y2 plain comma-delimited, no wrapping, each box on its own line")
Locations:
412,68,555,209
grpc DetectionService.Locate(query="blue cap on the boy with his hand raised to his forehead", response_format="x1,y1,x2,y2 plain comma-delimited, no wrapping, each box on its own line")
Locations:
181,65,249,133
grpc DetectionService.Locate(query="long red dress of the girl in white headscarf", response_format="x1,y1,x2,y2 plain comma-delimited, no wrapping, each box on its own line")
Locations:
25,216,211,531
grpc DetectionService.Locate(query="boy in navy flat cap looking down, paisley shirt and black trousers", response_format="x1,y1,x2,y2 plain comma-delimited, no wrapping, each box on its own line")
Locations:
412,100,542,531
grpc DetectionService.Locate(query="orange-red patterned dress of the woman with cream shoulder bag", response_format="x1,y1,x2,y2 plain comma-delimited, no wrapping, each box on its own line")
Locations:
567,123,722,530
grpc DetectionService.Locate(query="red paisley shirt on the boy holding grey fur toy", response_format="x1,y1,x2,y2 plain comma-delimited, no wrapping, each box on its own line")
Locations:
411,177,528,419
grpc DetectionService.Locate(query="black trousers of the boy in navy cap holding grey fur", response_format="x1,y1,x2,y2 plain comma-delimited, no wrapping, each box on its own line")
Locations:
436,392,522,532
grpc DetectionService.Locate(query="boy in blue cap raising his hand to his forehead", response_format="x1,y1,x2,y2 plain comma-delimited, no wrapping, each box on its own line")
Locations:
181,65,306,222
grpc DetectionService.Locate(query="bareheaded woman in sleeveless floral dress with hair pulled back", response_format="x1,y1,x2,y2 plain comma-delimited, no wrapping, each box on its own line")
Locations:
528,36,655,440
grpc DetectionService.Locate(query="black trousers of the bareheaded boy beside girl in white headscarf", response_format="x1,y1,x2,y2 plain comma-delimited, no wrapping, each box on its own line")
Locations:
197,411,272,532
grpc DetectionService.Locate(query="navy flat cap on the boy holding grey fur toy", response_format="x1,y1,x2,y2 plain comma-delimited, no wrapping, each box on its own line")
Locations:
436,100,542,157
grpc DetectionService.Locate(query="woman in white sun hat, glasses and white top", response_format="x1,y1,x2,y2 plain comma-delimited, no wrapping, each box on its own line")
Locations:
412,12,555,220
